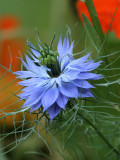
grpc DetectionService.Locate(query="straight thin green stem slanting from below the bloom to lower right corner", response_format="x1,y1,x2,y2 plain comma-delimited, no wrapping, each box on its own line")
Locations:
78,112,120,157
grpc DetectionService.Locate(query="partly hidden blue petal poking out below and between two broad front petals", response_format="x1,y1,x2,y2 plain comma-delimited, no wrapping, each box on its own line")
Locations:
56,93,69,109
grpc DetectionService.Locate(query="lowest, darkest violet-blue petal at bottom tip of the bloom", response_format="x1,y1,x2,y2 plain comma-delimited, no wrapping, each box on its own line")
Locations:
47,103,61,120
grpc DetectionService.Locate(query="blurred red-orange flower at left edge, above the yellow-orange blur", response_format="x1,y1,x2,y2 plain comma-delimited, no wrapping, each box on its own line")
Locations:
0,16,24,71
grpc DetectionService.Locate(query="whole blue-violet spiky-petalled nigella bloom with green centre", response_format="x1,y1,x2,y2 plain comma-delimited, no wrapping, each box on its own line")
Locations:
15,36,102,120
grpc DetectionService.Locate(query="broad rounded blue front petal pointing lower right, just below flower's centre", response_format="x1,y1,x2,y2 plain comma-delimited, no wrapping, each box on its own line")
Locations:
59,82,78,98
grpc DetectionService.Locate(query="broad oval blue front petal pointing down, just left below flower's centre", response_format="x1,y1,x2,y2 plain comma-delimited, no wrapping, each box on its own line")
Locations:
42,84,59,111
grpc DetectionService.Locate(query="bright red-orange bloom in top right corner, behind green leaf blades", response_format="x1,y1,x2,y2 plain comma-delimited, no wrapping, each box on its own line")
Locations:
76,0,120,38
